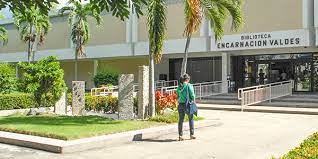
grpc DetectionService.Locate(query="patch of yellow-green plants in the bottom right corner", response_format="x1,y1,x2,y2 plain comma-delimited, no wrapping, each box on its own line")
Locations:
273,133,318,159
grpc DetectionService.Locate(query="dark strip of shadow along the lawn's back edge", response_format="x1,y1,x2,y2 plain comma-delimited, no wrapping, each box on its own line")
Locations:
0,116,123,126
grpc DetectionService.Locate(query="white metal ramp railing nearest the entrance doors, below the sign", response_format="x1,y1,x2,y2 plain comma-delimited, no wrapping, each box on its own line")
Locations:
238,80,294,111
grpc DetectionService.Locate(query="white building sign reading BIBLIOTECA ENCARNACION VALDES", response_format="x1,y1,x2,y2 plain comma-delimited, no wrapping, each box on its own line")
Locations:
212,30,309,51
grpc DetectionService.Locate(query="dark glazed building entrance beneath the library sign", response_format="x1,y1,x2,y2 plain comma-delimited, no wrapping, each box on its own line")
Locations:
231,53,318,92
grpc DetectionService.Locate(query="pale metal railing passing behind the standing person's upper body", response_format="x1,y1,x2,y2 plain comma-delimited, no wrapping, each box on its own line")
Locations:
160,81,230,100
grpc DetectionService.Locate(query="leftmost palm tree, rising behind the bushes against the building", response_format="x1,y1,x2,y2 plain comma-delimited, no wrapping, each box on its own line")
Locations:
13,6,51,63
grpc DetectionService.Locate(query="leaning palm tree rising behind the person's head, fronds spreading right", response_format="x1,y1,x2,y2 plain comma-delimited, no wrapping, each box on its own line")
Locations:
181,0,243,75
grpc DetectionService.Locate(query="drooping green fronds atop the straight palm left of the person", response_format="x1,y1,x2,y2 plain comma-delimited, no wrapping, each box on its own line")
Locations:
147,0,166,63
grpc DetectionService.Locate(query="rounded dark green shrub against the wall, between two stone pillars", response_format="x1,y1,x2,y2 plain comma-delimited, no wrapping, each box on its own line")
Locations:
93,69,119,87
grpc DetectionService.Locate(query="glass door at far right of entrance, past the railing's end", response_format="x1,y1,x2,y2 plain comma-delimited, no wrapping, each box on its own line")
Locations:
294,61,311,92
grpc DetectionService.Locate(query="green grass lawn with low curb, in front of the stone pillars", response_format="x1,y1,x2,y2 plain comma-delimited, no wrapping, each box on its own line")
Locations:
0,115,164,140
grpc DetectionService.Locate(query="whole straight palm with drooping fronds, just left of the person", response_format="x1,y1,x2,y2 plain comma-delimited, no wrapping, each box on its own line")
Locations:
147,0,166,116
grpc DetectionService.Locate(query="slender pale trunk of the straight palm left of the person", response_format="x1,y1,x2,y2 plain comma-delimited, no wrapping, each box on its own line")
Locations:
149,51,156,117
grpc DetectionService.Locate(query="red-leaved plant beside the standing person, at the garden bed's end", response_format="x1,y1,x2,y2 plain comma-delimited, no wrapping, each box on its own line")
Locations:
155,91,178,114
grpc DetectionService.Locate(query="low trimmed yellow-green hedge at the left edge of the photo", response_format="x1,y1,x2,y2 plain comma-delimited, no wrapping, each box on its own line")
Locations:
0,93,37,110
